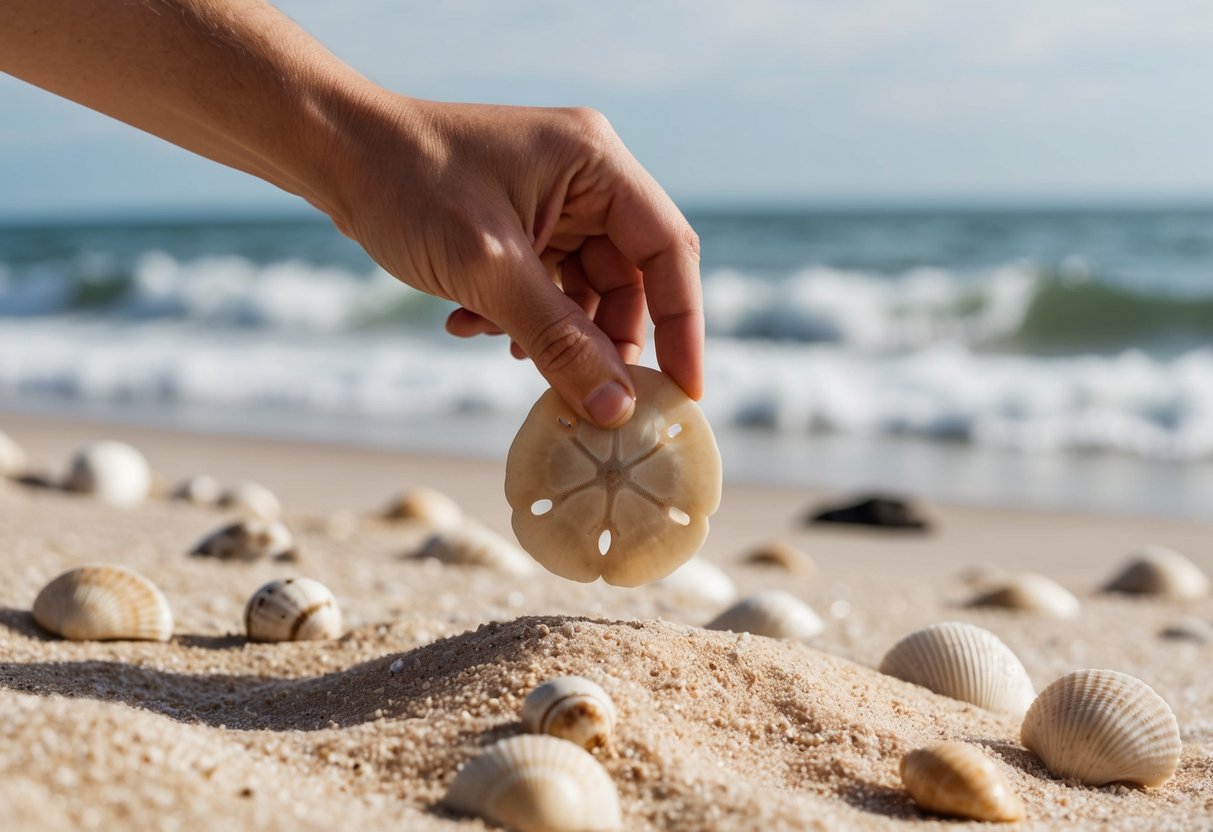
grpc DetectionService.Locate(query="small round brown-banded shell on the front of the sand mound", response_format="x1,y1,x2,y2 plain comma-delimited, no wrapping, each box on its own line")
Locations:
523,676,616,751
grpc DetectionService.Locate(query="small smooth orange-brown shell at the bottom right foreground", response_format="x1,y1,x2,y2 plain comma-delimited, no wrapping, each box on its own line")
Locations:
901,742,1024,822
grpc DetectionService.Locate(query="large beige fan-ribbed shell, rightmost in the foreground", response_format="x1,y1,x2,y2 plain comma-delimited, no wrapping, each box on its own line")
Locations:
1020,669,1183,786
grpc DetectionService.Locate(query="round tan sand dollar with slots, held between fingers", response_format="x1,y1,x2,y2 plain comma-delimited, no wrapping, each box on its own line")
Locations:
506,366,721,587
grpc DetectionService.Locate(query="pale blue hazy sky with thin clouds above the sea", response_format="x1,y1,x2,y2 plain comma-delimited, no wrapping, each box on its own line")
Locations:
0,0,1213,218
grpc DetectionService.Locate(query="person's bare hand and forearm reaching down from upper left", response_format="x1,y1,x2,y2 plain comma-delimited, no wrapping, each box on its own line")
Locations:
0,0,704,427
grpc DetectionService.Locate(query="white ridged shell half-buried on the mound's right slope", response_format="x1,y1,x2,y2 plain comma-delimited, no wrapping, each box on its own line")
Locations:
881,621,1036,716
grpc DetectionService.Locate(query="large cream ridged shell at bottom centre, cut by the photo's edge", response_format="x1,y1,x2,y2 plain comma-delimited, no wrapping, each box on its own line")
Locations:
443,734,623,832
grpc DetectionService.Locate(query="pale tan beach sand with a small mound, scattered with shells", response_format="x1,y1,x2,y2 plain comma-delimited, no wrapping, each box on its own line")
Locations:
0,416,1213,831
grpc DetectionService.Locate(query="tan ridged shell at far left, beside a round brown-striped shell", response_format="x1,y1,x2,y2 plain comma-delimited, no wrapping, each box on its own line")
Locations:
34,565,172,642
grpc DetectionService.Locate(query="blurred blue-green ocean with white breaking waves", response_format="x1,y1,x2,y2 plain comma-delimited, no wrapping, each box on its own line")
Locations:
0,207,1213,519
